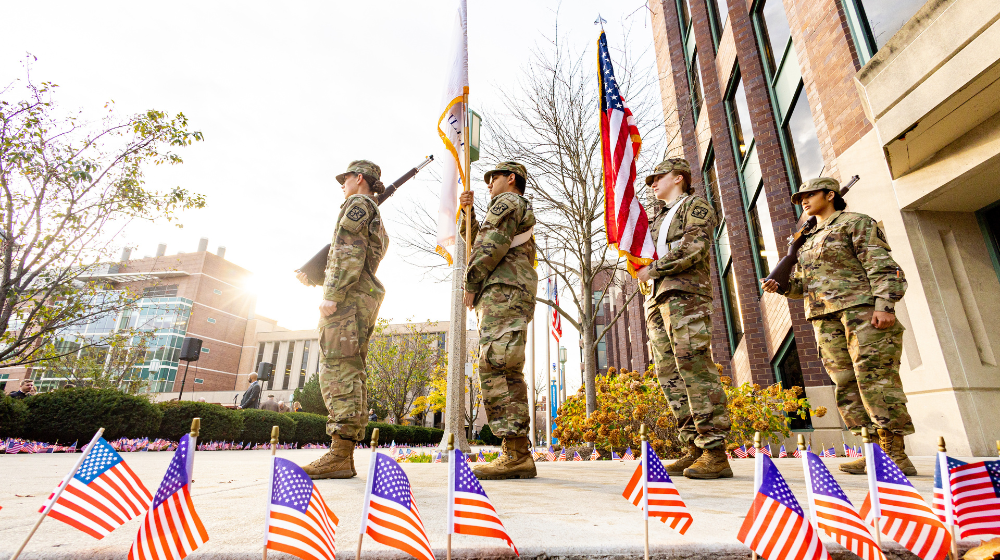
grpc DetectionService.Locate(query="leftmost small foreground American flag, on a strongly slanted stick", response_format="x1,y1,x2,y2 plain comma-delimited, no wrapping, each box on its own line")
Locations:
38,438,153,539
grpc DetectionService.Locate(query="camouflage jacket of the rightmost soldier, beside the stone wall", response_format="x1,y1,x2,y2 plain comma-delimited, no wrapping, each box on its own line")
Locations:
785,211,906,319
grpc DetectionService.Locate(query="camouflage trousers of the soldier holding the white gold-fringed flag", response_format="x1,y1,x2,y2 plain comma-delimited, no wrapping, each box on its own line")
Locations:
476,284,535,438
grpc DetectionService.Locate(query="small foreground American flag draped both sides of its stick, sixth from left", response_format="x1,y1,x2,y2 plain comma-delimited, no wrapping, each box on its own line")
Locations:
622,441,694,535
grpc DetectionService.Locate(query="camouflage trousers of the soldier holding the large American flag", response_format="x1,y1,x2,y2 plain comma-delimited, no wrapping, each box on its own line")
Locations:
646,291,730,449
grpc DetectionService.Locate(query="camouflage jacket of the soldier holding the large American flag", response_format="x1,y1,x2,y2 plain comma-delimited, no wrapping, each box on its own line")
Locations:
649,195,716,299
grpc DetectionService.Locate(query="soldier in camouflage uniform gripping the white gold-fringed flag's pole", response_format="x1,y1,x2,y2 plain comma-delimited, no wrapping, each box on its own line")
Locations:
461,161,538,480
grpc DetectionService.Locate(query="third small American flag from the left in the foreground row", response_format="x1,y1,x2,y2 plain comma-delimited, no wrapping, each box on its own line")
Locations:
264,457,339,560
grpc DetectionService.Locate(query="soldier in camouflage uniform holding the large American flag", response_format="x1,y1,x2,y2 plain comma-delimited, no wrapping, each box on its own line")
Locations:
638,158,733,479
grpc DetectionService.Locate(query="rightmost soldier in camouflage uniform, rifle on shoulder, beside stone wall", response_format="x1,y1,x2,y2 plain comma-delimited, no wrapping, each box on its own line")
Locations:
763,177,917,475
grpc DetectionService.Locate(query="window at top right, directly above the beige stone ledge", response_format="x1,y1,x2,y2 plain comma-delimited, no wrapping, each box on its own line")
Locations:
842,0,927,64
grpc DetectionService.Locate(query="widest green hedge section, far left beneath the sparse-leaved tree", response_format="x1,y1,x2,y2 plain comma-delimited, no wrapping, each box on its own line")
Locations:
24,387,163,444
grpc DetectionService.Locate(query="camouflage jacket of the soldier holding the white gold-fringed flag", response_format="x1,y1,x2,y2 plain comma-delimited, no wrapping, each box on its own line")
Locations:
460,192,538,299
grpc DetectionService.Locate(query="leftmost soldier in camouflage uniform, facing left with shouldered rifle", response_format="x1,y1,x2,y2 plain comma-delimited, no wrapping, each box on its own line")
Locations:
300,160,389,478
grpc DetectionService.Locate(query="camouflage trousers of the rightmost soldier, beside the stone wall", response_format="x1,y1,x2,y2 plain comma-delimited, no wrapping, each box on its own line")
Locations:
812,305,914,435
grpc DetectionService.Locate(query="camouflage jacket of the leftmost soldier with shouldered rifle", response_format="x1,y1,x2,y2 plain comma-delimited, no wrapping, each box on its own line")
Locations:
323,194,389,303
